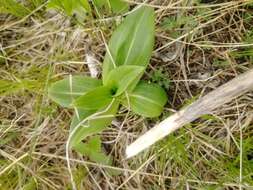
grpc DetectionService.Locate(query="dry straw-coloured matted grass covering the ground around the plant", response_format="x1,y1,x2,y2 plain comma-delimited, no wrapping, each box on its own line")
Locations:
0,0,253,190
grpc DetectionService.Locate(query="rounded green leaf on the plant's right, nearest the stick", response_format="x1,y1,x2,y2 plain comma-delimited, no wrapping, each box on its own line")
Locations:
123,81,167,117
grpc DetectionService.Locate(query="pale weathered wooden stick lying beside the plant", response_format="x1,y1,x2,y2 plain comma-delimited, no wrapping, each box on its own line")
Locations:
126,69,253,158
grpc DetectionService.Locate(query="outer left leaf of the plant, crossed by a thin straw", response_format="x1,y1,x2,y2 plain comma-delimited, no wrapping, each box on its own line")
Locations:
48,76,102,107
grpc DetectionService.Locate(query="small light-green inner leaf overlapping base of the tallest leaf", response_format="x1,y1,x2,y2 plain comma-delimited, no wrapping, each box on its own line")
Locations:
104,65,145,96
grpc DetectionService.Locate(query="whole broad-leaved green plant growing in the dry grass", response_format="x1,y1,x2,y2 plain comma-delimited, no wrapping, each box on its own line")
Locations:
49,7,167,168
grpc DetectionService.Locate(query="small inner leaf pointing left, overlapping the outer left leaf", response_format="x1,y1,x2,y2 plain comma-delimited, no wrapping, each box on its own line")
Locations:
73,86,112,110
